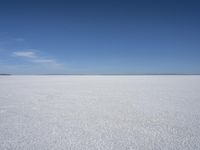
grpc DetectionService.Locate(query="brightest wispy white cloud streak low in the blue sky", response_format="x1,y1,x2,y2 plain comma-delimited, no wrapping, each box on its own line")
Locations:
12,50,62,66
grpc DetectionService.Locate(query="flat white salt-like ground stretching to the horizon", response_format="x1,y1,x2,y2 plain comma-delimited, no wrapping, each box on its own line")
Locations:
0,76,200,150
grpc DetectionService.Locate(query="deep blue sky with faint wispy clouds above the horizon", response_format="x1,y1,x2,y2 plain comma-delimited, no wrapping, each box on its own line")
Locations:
0,0,200,74
